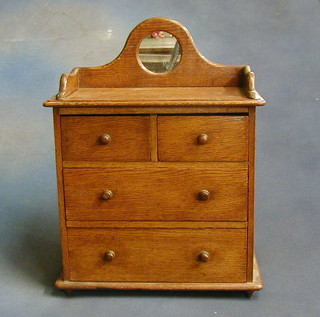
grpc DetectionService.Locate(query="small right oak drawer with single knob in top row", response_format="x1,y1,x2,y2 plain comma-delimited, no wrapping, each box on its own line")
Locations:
158,115,248,161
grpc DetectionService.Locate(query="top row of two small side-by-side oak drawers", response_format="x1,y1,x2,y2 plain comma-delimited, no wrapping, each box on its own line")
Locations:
61,115,248,162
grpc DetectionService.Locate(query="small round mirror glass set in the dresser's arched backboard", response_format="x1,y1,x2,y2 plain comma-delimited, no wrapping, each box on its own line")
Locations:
139,31,181,73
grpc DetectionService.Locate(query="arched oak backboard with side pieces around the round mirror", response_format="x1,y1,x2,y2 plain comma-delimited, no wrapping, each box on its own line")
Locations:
48,18,261,100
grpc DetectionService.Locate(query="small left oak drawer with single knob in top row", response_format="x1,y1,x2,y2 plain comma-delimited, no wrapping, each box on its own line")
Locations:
61,116,150,161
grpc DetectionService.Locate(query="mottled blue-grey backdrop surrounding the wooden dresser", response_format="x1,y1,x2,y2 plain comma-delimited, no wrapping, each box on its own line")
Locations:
0,0,320,317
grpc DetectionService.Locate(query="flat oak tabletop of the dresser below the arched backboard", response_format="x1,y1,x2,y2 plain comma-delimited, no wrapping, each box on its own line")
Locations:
44,87,265,107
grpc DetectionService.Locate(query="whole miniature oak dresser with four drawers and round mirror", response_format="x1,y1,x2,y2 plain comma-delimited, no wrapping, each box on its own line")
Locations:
44,18,265,296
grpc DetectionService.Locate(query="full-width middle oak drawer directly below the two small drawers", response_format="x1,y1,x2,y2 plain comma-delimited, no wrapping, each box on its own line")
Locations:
64,163,248,221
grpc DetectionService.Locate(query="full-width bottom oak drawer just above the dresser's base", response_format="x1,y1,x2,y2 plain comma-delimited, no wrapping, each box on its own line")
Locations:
68,228,247,282
